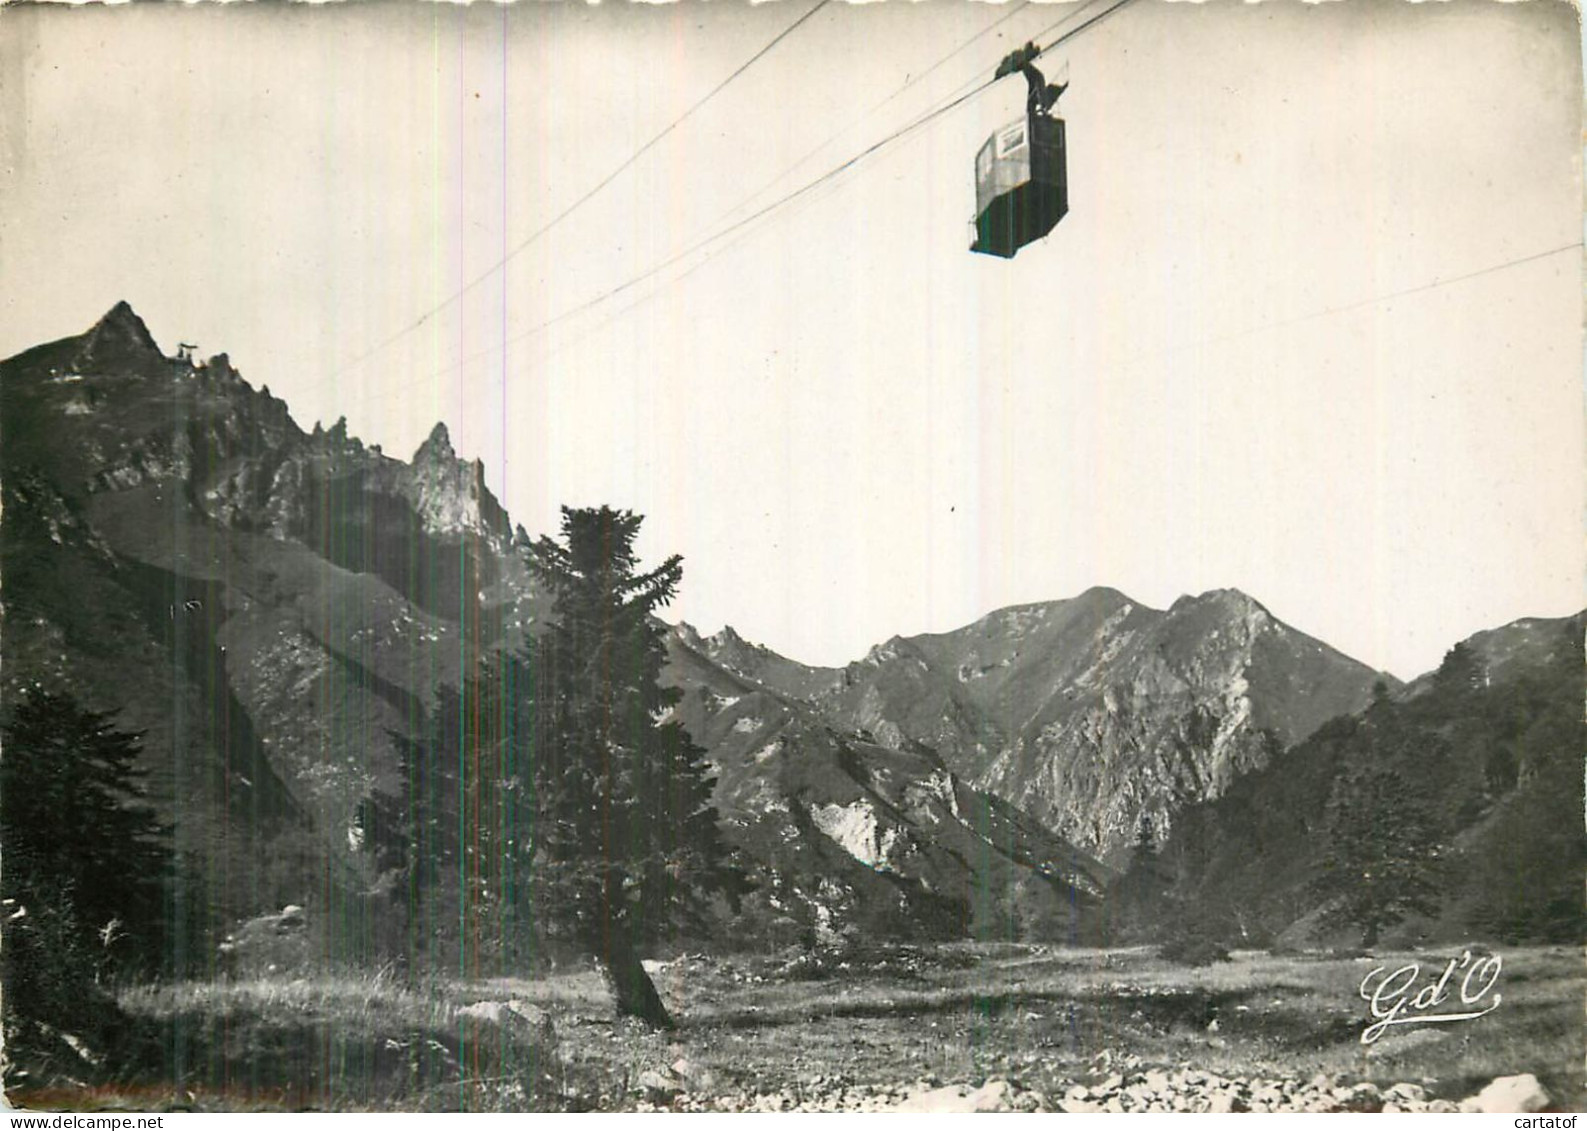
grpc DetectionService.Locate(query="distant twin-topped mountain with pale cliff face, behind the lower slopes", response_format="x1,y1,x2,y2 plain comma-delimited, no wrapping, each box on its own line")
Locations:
689,589,1395,858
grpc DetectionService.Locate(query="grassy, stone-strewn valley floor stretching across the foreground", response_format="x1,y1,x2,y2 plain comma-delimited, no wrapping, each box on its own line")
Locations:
80,944,1587,1112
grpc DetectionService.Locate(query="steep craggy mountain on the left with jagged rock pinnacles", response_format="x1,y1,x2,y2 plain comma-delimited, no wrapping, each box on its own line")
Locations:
0,303,543,912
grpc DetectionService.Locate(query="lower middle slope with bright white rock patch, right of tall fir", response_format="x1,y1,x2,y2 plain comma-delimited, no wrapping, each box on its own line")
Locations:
668,630,1108,941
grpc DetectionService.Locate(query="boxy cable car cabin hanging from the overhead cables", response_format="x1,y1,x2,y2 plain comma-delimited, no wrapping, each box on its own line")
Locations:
970,43,1070,259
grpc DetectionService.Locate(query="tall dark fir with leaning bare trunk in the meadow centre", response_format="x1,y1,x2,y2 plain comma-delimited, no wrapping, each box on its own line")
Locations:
530,506,740,1026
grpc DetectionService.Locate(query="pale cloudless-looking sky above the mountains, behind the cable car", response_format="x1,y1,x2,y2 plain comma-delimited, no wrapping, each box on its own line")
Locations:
0,0,1587,677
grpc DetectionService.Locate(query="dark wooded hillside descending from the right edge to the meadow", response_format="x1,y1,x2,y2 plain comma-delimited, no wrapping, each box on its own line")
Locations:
1165,614,1587,942
